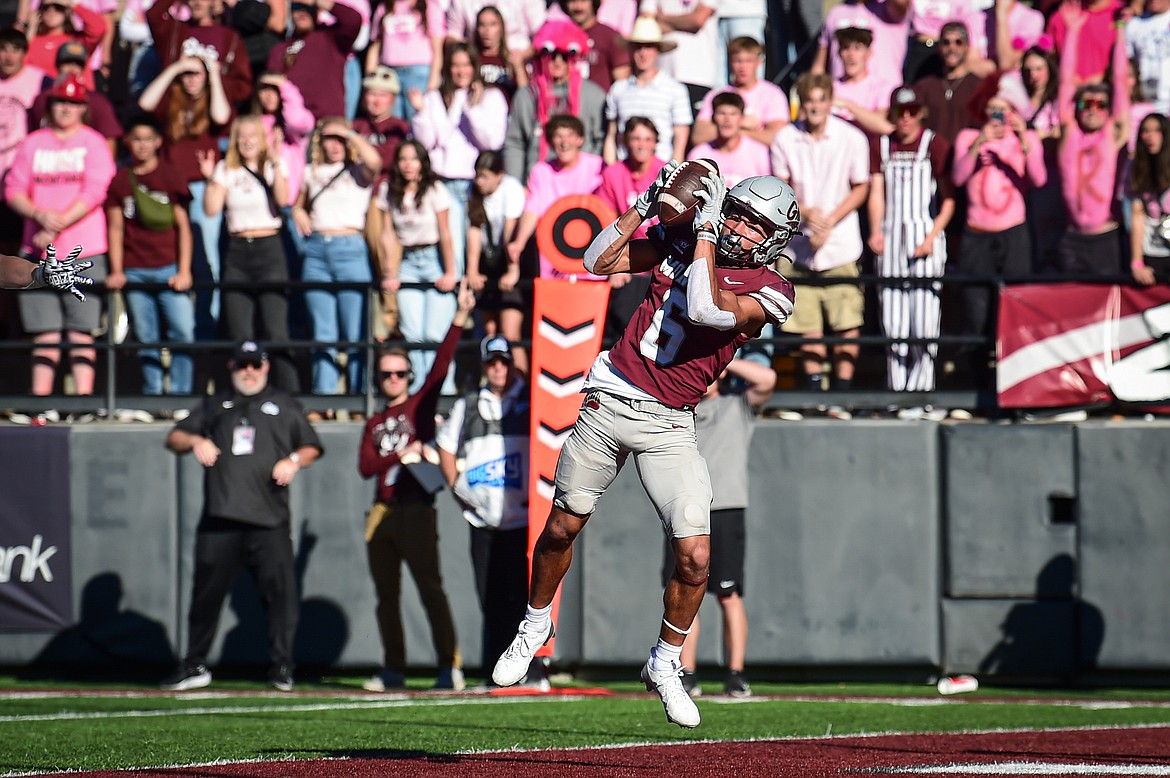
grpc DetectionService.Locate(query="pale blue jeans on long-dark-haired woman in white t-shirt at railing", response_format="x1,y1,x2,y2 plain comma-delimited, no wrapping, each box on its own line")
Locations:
398,246,456,392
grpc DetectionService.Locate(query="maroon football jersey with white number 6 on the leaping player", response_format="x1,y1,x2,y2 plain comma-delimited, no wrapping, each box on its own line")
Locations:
610,230,796,408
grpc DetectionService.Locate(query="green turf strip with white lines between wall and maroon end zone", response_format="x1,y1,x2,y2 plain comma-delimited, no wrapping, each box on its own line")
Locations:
0,677,1170,776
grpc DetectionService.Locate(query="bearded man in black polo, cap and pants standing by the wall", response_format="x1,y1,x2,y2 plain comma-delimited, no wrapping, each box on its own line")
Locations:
163,340,324,691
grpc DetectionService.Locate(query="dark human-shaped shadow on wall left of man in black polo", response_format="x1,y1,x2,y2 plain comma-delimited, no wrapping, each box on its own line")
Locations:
25,572,176,680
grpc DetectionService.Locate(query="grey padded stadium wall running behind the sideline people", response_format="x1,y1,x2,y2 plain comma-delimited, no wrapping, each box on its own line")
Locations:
0,420,1170,677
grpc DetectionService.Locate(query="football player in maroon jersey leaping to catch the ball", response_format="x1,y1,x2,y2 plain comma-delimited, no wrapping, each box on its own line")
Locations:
491,163,800,729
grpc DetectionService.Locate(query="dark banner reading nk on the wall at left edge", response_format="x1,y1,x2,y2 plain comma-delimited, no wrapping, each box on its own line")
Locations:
0,428,73,632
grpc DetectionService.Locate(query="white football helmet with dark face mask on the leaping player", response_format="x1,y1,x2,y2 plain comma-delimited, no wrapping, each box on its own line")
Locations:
715,175,804,267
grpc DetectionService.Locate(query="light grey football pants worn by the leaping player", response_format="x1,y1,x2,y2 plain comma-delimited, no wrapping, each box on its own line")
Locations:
552,391,711,537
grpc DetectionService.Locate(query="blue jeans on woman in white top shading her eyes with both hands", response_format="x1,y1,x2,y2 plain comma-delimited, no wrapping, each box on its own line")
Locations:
303,233,373,394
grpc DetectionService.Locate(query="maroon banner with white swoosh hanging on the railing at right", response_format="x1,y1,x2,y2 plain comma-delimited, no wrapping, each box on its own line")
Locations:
996,283,1170,408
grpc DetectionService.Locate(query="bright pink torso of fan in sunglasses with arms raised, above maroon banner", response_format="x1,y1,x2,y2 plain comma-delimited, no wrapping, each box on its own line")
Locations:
1057,122,1117,233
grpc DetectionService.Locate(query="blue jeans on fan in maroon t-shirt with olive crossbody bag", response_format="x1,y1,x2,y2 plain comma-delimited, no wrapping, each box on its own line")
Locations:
126,264,195,394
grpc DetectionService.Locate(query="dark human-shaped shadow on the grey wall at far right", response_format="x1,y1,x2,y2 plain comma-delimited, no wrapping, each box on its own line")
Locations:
978,553,1104,681
